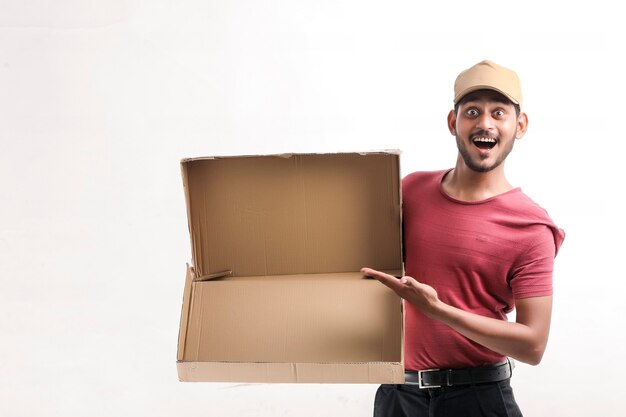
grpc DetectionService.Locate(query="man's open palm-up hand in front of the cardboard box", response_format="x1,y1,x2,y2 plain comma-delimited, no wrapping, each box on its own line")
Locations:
361,268,442,317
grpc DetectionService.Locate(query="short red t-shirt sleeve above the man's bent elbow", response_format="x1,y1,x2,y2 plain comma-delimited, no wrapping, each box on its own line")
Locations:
509,226,556,299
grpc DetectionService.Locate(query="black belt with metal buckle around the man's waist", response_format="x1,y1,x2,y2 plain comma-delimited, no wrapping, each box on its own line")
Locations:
404,359,515,388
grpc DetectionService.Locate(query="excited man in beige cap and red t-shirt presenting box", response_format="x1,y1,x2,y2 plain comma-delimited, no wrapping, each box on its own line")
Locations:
362,61,565,417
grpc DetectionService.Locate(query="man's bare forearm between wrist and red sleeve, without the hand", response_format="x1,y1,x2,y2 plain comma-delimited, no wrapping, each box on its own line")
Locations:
429,300,551,365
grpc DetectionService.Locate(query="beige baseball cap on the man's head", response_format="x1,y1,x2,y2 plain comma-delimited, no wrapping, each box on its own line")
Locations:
454,60,522,107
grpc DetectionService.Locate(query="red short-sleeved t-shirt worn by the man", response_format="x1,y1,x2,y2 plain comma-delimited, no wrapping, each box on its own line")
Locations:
402,171,565,370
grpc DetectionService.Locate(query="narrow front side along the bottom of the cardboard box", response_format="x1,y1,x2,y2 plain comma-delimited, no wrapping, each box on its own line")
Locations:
177,361,404,384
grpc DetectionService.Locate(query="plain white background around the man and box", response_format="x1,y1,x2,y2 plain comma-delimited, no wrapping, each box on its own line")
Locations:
0,0,626,417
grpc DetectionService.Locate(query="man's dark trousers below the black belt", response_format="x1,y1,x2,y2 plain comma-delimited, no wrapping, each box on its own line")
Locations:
374,379,522,417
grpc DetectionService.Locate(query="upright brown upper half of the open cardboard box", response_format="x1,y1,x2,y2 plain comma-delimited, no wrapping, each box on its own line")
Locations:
181,152,402,277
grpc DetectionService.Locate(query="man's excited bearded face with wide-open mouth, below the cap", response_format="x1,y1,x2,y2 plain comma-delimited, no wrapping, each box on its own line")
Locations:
448,90,527,172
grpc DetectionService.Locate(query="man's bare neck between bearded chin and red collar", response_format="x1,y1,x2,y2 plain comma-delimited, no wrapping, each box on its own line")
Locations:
442,158,513,201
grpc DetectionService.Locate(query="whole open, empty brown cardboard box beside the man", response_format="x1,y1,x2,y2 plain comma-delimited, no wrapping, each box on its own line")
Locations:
177,152,404,383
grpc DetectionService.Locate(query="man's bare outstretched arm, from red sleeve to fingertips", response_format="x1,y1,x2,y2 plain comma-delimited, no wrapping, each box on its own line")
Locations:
361,268,552,365
